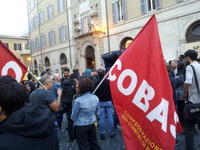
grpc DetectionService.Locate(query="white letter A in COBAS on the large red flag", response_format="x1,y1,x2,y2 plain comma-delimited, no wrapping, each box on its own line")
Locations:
146,99,169,132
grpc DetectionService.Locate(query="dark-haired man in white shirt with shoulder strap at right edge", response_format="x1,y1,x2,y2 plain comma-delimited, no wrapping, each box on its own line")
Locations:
184,49,200,150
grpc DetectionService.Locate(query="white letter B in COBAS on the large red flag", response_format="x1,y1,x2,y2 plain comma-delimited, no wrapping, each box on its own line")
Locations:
132,80,155,112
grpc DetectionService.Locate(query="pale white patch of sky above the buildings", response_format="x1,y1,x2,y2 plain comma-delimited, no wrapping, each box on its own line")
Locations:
0,0,28,36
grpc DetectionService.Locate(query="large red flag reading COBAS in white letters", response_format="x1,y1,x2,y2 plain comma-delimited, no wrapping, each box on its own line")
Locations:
109,15,180,150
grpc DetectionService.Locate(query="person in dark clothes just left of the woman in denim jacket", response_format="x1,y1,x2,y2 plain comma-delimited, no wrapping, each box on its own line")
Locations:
61,73,76,145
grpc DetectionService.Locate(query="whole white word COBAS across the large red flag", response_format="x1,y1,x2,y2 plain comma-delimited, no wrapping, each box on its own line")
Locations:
108,59,179,138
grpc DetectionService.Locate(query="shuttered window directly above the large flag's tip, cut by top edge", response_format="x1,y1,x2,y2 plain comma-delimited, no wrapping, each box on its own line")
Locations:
141,0,160,14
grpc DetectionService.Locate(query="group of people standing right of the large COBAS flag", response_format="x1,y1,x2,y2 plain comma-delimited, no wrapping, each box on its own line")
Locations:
167,50,200,150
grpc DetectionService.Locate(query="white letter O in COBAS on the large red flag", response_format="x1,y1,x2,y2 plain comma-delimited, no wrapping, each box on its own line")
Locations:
117,69,137,95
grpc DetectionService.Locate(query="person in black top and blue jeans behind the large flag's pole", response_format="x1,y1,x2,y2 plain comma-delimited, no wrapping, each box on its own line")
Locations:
96,69,115,140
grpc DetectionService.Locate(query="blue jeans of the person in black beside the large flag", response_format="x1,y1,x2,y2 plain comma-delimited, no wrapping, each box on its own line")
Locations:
99,101,114,135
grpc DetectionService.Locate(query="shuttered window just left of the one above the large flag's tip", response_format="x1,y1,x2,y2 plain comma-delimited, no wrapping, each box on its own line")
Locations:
112,0,127,23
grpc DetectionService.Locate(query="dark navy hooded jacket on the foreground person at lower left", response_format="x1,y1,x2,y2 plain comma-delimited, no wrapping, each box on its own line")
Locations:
0,104,59,150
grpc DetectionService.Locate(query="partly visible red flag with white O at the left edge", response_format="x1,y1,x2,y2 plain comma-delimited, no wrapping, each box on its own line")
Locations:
0,41,27,82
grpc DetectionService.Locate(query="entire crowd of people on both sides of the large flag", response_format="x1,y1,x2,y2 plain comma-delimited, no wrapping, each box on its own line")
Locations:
0,50,200,150
